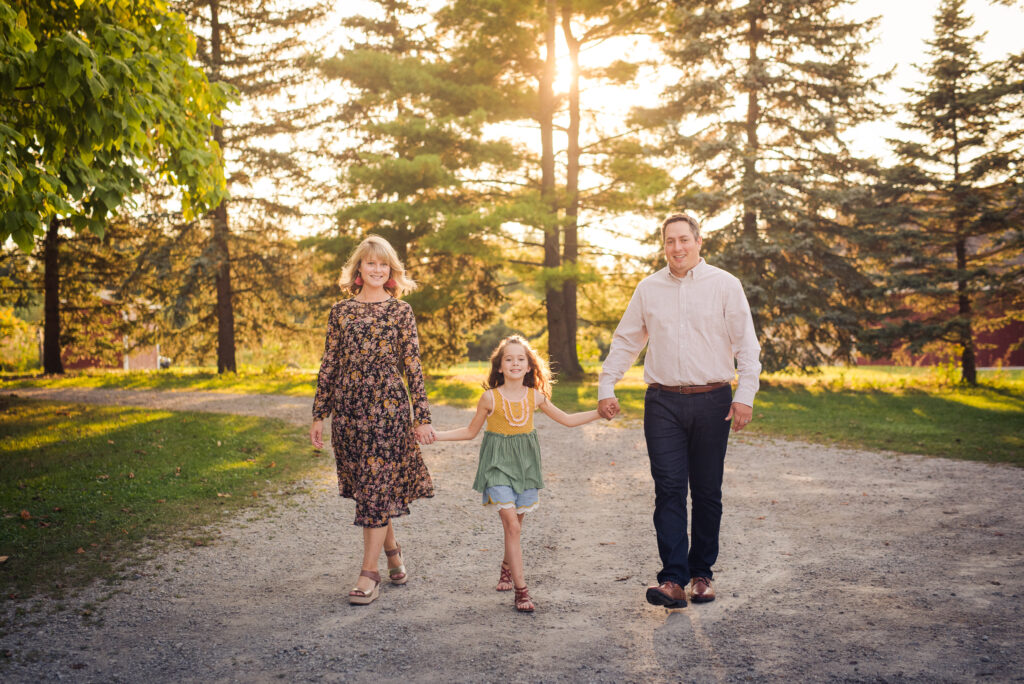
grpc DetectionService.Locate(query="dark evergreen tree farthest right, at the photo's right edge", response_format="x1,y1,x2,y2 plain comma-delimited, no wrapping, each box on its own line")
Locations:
867,0,1024,385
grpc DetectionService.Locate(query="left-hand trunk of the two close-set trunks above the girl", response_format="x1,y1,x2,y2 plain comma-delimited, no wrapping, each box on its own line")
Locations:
538,0,574,373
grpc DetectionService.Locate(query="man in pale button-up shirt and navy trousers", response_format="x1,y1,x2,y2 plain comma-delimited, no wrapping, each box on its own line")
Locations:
597,214,761,608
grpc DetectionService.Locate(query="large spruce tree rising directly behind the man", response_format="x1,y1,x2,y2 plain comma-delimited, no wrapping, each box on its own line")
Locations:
637,0,881,371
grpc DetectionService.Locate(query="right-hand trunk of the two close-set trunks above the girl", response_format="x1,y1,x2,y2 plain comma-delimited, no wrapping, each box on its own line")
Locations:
561,6,583,380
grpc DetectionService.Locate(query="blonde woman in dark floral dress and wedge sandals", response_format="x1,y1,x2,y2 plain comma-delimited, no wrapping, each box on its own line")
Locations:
309,236,435,605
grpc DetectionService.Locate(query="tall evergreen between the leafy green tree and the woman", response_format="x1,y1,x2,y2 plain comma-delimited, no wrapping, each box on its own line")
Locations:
174,0,330,373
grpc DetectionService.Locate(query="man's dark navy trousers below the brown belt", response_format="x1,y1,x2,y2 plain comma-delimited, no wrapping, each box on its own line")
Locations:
643,385,732,586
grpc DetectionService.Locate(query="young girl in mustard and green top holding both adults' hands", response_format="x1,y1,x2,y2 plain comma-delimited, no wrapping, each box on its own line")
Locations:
437,335,599,612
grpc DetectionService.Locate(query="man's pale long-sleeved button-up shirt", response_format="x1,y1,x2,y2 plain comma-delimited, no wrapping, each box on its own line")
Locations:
597,259,761,407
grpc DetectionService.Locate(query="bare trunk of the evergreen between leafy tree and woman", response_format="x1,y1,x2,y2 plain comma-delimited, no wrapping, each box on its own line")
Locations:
210,0,238,373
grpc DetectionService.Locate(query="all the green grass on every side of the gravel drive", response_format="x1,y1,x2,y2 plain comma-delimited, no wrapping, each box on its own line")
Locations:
0,364,1024,598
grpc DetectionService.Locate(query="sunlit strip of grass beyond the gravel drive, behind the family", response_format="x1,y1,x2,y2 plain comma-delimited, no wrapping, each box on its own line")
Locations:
0,362,1024,466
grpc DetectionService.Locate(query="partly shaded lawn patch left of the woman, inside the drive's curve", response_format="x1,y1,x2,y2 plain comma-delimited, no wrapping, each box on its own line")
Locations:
0,397,324,597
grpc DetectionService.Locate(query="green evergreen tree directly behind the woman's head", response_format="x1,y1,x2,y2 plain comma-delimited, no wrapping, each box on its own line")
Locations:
310,0,516,366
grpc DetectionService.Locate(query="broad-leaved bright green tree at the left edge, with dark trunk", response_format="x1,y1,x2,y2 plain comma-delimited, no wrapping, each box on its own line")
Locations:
0,0,226,373
